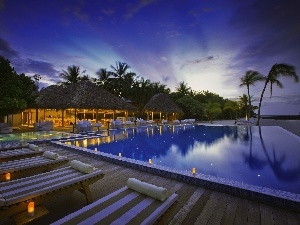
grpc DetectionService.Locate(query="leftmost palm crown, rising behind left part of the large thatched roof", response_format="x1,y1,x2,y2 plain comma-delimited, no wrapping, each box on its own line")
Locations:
59,65,89,84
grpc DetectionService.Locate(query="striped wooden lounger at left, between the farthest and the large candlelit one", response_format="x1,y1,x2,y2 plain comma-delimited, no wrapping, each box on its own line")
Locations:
0,156,69,182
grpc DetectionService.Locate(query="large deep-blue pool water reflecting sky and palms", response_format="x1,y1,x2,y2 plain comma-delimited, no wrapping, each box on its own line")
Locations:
63,125,300,194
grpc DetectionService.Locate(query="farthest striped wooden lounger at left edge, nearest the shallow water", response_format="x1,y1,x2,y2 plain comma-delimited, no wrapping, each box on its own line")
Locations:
0,148,44,162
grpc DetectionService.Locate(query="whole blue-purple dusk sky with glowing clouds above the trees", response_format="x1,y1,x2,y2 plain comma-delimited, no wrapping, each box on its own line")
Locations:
0,0,300,115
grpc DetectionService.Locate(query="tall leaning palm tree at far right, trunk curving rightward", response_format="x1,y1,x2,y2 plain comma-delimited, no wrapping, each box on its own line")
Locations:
256,64,299,126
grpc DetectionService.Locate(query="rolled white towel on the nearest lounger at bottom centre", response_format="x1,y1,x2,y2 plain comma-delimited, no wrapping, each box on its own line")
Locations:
127,178,169,201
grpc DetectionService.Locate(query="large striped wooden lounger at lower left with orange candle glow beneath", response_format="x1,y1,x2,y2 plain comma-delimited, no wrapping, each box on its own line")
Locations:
0,166,104,218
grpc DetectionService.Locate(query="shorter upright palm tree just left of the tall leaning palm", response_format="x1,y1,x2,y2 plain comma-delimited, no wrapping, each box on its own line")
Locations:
240,70,264,119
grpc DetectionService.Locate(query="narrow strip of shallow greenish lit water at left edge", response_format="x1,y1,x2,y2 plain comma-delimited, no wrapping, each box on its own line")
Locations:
0,131,72,143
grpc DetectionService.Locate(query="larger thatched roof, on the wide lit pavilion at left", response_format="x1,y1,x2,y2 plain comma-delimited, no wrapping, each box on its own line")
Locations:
37,81,134,110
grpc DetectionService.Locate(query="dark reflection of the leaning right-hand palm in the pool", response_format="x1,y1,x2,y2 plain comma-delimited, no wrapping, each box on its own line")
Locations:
259,126,300,181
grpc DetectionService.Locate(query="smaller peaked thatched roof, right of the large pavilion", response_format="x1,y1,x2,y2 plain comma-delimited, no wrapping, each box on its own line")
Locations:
143,93,183,114
